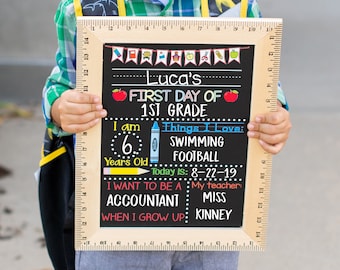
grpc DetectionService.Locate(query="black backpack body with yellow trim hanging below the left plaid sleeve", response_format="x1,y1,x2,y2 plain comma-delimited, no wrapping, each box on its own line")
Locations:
38,129,75,270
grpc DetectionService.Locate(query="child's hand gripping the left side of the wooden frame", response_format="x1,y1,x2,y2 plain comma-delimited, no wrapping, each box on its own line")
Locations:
51,90,107,133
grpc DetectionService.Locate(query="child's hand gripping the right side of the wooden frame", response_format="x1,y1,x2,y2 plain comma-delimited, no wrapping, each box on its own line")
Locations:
248,103,292,154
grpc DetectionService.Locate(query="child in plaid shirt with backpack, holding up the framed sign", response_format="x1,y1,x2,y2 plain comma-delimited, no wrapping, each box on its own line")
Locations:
39,0,291,270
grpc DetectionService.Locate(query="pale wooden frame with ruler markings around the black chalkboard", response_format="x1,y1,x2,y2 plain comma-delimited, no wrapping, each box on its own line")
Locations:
75,17,282,251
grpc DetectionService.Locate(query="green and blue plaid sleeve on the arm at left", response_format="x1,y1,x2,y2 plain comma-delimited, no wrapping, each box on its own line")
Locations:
42,0,76,136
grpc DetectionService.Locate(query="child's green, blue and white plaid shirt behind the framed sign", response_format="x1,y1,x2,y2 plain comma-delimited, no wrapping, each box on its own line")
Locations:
42,0,285,136
